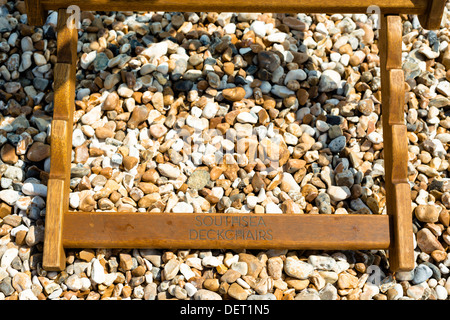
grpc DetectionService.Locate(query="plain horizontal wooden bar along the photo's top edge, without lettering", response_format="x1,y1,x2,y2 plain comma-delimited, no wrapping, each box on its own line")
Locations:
42,0,428,14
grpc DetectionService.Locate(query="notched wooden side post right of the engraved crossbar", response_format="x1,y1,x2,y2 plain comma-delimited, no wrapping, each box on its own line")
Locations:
379,14,414,272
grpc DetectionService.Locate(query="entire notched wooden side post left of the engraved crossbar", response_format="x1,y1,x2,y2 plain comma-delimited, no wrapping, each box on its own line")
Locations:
43,9,78,271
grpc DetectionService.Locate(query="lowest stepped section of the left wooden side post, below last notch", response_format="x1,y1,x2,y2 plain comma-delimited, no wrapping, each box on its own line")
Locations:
42,179,68,271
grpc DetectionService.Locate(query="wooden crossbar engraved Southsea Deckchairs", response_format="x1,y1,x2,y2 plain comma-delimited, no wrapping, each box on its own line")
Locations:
63,211,390,250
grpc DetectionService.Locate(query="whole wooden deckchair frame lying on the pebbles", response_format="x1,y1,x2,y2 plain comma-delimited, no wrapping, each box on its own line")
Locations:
25,0,445,272
